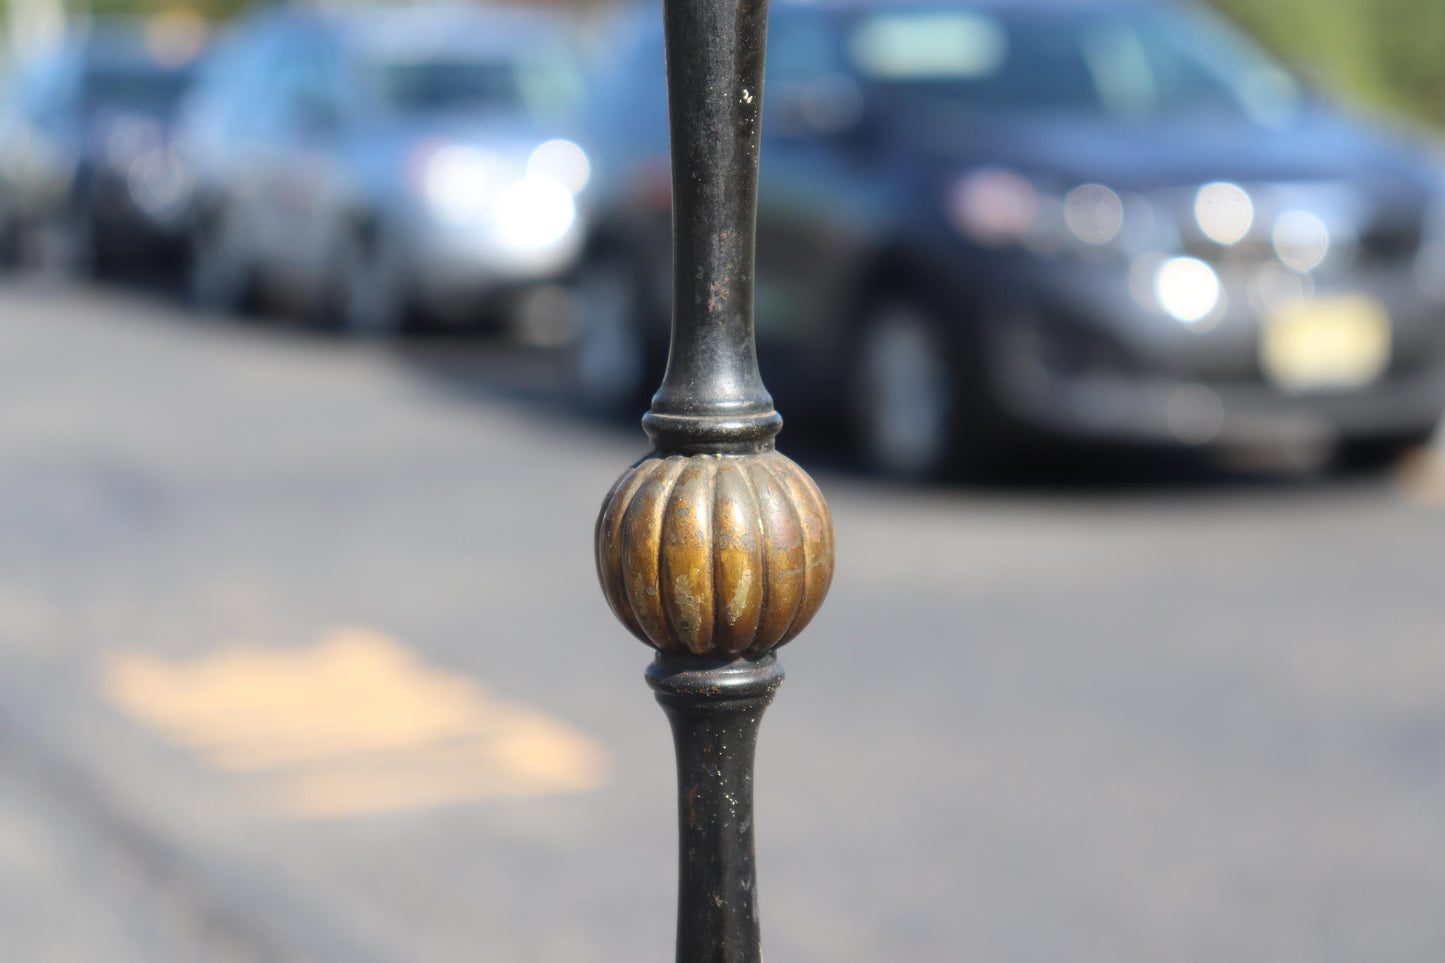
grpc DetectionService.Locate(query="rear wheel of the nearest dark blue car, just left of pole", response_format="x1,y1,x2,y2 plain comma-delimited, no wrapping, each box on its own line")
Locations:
566,256,649,415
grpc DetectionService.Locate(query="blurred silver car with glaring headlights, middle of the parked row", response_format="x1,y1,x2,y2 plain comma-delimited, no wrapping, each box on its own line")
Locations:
181,6,590,334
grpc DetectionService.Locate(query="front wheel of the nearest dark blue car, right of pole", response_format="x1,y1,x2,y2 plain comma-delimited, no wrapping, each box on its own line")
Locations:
853,299,957,480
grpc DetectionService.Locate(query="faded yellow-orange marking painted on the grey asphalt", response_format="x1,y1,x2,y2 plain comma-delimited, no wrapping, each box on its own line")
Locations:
103,629,607,817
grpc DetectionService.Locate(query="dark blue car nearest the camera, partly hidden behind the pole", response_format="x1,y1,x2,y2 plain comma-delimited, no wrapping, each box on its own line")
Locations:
571,0,1445,476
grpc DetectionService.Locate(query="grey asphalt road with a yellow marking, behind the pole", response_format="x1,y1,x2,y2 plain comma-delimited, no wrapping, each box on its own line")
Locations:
0,277,1445,963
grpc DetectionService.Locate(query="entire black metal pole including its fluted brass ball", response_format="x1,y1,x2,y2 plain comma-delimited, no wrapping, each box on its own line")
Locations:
595,0,834,963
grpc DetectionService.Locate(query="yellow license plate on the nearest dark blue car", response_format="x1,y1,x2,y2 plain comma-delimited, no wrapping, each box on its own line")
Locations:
1260,295,1390,392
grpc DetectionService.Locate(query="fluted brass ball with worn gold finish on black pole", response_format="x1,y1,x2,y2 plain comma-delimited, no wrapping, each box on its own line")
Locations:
597,451,832,658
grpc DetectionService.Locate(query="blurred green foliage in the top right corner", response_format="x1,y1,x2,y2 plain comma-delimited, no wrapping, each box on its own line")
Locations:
1212,0,1445,127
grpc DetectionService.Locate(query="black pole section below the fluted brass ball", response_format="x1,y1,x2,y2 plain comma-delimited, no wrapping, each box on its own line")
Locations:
647,654,783,963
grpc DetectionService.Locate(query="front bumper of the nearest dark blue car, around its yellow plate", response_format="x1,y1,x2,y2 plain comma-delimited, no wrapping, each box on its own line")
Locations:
985,254,1445,445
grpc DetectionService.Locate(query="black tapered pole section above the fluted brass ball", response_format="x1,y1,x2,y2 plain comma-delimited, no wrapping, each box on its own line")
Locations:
643,0,782,453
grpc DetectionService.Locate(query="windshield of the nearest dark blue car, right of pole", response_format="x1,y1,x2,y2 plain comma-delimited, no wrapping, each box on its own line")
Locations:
848,4,1301,123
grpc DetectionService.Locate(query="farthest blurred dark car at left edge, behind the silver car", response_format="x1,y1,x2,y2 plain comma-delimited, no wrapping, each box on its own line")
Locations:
0,16,205,275
